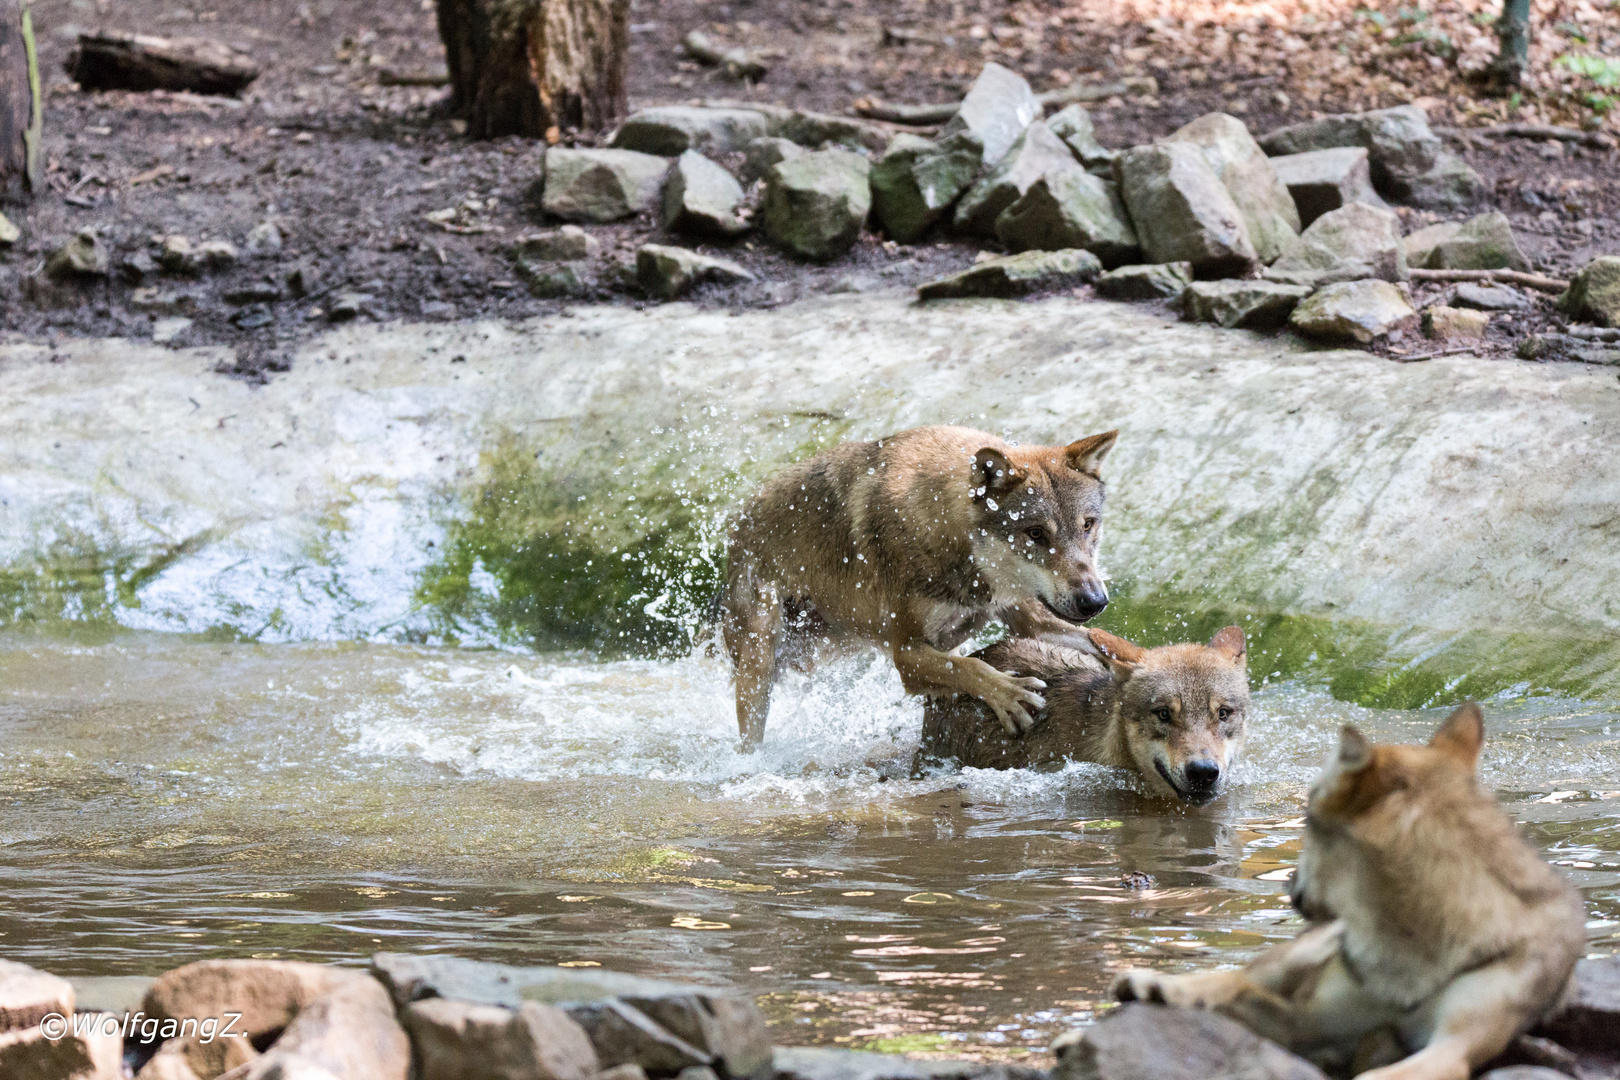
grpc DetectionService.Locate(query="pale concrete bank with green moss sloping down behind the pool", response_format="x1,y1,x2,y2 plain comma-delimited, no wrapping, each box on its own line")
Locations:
0,295,1620,703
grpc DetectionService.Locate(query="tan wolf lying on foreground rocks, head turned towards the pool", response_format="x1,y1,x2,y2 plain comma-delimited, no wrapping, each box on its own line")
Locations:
1115,704,1586,1080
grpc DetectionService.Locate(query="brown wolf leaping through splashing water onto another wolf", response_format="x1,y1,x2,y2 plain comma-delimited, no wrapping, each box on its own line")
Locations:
721,427,1118,746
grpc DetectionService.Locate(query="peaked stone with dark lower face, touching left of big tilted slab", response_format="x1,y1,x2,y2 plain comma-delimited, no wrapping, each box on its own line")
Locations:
996,170,1142,266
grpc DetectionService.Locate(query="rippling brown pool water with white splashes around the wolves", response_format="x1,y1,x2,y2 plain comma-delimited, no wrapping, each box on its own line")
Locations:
0,633,1620,1056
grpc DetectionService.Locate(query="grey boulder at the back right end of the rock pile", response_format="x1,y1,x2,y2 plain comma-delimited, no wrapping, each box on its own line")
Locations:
1260,105,1484,210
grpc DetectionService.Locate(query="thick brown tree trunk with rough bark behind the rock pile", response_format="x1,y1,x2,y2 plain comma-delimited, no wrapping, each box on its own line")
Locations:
439,0,630,139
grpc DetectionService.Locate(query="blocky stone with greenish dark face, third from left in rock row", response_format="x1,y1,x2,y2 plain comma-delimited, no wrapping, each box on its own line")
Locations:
760,151,872,262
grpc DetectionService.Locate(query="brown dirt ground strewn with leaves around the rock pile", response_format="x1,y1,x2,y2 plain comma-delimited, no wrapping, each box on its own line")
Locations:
0,0,1620,379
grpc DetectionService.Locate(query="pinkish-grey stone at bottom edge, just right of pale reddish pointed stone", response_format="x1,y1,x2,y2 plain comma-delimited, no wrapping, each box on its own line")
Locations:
403,997,598,1080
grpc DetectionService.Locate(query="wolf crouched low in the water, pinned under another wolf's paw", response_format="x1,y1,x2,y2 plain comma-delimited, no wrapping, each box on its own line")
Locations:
917,627,1249,803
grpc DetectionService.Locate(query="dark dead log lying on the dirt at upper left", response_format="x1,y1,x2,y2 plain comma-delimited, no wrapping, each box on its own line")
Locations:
63,32,259,97
